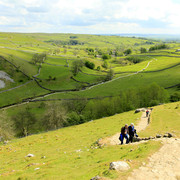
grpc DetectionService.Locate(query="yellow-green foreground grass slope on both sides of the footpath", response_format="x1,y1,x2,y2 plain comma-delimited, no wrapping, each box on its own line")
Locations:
0,102,180,180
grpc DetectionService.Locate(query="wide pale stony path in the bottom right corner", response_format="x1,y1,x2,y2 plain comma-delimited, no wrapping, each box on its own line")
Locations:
128,138,180,180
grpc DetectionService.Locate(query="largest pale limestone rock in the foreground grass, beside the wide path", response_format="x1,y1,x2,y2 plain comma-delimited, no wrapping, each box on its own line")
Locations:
109,161,130,171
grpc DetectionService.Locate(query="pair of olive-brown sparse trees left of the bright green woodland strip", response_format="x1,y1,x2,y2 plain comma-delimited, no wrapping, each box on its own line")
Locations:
11,103,67,137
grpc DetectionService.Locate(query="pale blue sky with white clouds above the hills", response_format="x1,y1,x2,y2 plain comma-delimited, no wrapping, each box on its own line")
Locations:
0,0,180,34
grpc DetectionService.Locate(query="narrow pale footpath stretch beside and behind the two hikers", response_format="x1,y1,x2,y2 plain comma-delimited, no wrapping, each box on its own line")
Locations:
99,109,151,145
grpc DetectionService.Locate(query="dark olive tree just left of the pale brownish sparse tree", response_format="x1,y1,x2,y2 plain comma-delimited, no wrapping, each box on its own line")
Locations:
12,108,36,136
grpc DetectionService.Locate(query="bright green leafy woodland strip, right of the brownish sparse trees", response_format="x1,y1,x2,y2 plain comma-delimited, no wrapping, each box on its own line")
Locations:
65,84,169,126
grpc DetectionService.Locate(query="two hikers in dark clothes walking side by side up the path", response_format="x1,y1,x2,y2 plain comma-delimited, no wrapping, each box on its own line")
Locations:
119,123,138,144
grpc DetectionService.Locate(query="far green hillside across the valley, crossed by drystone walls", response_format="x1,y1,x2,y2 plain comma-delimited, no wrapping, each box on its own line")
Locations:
0,33,180,106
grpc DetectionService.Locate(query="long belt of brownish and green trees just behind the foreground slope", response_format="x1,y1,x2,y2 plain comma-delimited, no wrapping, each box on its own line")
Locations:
9,83,169,137
